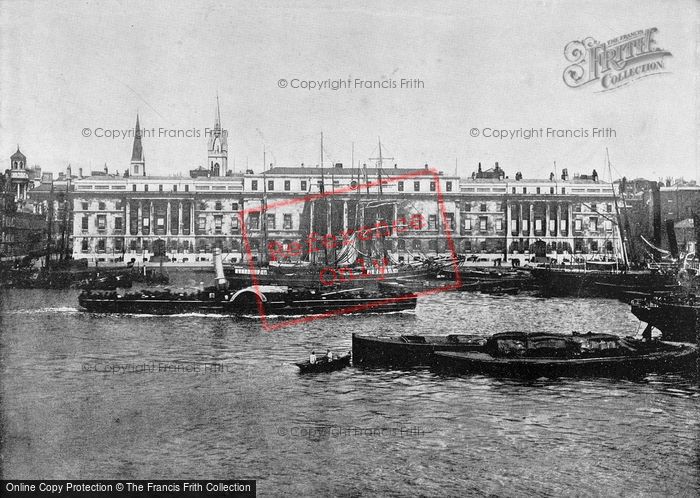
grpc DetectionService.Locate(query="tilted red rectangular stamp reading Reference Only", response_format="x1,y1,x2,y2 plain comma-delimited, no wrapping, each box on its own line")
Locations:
240,169,462,331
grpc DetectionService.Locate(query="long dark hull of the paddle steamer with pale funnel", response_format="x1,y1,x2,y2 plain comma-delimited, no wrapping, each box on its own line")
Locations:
78,295,417,316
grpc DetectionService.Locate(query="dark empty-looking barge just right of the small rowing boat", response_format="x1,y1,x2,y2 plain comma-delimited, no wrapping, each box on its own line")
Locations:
352,334,485,368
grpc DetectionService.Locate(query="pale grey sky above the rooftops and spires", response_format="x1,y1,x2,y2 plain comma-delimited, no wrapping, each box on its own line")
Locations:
0,0,700,183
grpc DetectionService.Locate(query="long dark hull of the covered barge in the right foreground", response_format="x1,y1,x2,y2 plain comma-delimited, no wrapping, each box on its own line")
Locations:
434,346,697,378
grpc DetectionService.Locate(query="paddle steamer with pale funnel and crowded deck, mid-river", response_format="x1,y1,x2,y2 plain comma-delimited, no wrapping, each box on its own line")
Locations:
78,250,417,316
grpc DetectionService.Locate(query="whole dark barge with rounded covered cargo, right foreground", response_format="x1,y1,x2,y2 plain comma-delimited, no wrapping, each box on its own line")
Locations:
434,332,697,378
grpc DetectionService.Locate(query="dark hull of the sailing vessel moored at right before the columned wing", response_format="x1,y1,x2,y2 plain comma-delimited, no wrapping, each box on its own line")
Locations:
531,268,678,299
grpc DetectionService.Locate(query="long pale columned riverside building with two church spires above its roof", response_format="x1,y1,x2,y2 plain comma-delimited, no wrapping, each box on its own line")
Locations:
72,106,620,262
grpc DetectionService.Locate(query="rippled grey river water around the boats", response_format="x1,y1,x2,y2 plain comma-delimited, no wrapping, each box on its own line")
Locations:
0,290,700,496
